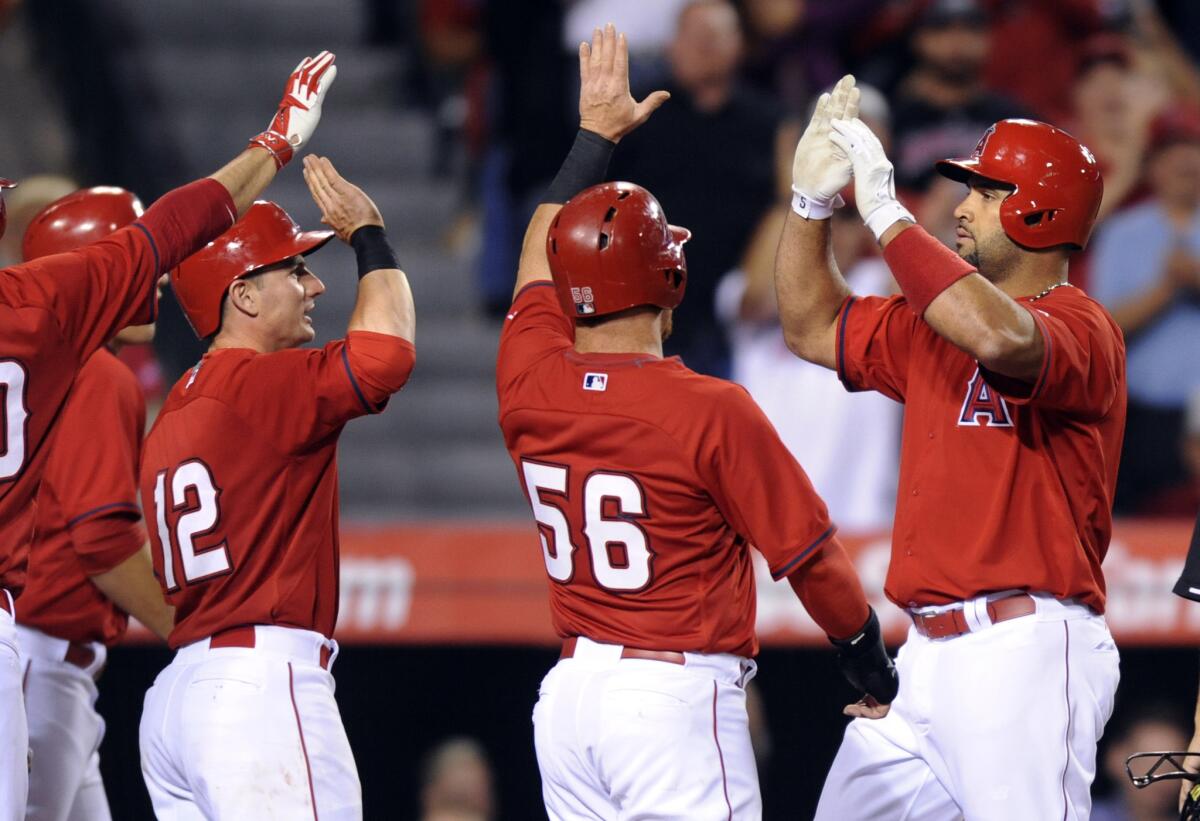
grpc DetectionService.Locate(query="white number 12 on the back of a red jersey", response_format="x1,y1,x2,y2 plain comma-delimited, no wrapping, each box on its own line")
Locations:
154,459,233,593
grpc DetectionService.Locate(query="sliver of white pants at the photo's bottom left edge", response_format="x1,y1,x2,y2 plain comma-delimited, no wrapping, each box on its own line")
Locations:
0,589,29,821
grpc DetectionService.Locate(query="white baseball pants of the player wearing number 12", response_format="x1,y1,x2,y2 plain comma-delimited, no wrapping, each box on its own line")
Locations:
140,625,362,821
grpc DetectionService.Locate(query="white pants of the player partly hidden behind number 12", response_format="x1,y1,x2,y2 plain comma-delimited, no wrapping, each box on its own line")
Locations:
17,624,112,821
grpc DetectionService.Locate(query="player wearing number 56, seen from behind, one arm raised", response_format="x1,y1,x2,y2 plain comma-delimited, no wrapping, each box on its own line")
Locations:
497,25,896,821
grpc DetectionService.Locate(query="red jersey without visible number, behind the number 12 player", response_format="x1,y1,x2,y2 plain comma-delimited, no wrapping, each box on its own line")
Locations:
17,348,146,645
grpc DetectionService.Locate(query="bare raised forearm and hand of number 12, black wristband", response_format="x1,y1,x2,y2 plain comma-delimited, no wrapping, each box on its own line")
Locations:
304,155,416,342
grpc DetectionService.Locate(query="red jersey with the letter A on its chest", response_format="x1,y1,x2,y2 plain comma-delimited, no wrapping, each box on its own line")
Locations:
836,287,1126,612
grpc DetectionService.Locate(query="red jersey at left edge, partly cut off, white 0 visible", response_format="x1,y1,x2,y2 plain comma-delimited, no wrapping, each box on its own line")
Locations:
0,180,235,595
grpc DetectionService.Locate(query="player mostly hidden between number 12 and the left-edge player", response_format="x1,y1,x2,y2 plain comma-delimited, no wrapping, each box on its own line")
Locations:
17,187,174,821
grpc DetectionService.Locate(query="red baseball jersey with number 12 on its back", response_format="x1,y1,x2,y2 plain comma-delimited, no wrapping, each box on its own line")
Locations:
140,331,414,647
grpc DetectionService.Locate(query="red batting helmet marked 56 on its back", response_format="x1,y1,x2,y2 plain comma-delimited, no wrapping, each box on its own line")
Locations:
546,182,691,317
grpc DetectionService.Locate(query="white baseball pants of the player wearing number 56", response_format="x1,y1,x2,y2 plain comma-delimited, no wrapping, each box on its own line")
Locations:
533,639,762,821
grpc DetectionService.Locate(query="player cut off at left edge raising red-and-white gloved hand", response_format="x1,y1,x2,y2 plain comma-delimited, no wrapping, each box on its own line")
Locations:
0,53,336,821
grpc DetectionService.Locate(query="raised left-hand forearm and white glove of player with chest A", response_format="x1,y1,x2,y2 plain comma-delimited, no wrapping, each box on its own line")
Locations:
775,76,858,368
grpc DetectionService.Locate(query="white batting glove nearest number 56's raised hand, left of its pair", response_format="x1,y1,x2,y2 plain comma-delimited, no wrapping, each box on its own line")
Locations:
792,74,858,220
